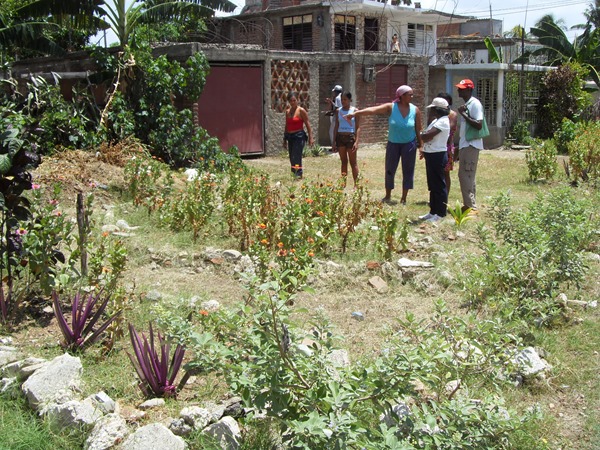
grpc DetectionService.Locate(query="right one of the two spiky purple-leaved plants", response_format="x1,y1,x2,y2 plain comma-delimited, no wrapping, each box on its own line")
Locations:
127,323,185,397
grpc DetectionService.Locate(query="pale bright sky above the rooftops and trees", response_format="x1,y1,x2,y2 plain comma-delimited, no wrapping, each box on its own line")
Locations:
95,0,593,45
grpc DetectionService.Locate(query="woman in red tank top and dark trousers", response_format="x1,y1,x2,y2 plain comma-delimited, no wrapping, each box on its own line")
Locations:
283,92,315,178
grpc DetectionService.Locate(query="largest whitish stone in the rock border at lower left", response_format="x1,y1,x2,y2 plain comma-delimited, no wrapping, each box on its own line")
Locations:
21,353,83,409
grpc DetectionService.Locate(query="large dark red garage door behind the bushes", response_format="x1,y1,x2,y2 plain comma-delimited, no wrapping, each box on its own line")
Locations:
198,66,265,154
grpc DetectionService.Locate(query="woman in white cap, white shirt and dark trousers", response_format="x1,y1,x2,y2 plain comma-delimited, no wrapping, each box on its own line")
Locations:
419,97,450,222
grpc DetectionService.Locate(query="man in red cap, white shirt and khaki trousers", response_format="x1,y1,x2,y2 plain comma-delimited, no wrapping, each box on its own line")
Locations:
456,79,484,211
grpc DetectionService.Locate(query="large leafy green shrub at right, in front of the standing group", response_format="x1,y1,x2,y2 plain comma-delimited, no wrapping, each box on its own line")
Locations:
463,188,594,323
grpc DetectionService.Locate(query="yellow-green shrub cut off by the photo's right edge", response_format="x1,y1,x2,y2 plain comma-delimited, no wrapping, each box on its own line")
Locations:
568,121,600,187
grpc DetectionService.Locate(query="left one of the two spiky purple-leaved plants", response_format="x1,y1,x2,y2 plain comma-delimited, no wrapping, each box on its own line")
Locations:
52,291,121,352
